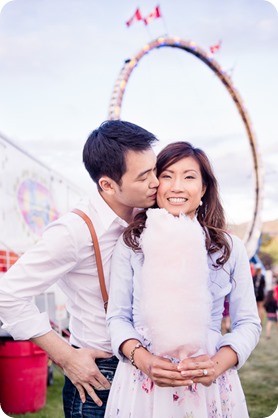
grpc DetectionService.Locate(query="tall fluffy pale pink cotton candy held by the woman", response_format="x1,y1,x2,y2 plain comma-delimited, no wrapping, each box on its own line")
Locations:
141,209,211,359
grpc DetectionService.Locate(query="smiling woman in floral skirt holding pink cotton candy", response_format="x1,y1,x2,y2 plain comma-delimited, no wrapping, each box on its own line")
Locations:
105,142,261,418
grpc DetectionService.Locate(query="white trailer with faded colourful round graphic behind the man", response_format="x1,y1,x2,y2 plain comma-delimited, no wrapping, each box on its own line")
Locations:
0,134,85,334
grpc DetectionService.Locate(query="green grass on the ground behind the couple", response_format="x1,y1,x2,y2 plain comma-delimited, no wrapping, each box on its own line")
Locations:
8,327,278,418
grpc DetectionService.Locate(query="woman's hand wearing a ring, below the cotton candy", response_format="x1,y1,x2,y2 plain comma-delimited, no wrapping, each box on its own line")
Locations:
178,354,217,386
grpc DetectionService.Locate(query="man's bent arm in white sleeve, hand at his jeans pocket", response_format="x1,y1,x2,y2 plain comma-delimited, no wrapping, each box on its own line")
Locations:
0,217,111,405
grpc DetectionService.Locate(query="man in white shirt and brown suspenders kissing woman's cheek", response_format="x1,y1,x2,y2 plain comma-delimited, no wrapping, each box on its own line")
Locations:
0,121,158,418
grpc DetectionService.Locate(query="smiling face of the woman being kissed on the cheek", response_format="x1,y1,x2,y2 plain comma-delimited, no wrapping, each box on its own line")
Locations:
157,157,206,218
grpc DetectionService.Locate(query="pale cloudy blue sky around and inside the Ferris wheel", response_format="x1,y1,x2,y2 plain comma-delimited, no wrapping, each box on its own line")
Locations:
0,0,278,222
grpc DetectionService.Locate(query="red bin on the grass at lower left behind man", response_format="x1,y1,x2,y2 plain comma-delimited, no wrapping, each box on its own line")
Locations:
0,339,48,414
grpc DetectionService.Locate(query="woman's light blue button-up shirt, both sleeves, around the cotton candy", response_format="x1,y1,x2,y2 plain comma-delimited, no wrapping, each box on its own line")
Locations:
107,236,261,369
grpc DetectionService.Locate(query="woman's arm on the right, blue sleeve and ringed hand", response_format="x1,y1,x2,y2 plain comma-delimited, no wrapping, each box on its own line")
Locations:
179,237,261,386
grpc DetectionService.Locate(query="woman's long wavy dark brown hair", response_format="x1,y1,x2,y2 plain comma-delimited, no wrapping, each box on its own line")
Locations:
124,141,231,267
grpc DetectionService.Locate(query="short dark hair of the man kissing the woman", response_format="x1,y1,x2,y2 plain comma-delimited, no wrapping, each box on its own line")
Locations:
83,120,157,188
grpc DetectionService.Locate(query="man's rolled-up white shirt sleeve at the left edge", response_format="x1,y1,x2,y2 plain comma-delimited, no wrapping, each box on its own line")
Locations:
0,223,76,340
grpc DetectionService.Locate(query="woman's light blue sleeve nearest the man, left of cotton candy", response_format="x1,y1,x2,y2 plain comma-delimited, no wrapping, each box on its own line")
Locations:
107,237,143,361
